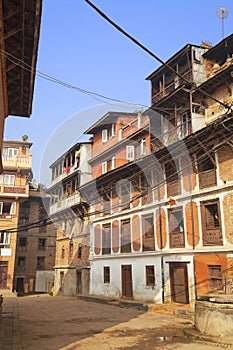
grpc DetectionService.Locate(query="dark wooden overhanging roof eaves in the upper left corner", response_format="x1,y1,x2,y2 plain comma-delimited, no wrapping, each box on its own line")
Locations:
0,0,42,173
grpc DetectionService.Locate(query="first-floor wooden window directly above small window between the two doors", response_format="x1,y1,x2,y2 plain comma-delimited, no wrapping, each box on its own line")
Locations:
142,214,155,252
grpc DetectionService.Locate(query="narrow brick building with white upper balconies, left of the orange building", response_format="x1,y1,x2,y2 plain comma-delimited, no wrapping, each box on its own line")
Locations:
48,142,92,296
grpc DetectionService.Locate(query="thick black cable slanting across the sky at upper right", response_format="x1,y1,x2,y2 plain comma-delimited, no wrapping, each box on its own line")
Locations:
84,0,232,110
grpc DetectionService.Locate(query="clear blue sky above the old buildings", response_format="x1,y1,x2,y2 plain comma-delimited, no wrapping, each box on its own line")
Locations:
5,0,233,185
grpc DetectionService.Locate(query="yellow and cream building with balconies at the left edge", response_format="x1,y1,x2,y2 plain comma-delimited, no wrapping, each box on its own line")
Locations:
0,141,32,294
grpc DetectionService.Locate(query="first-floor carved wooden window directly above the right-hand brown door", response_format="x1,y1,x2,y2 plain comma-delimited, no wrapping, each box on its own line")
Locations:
168,208,185,248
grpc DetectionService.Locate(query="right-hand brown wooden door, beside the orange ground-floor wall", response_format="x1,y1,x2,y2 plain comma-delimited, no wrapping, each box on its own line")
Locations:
170,263,189,304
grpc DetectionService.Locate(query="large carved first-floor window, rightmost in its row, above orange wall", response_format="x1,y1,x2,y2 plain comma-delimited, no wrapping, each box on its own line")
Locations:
202,201,223,245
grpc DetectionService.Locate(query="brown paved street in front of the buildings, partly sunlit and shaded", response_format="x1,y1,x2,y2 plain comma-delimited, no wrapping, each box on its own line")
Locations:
0,295,231,350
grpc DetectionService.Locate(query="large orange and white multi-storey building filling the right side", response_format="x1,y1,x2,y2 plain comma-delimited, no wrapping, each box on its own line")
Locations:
81,35,233,305
